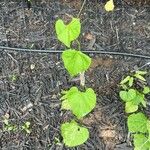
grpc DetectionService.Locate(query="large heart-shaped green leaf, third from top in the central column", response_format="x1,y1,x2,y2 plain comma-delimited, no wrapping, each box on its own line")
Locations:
63,87,96,118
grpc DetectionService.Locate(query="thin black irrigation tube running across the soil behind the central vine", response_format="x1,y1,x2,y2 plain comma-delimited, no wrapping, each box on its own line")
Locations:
0,46,150,59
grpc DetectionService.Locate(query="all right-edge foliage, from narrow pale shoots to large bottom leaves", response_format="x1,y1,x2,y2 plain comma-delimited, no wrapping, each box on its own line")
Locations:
119,71,150,150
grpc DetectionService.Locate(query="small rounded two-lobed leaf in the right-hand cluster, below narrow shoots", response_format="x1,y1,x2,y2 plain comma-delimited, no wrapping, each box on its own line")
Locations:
119,89,136,102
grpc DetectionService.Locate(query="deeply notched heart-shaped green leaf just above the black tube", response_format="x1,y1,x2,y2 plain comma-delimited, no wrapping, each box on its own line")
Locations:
55,18,81,47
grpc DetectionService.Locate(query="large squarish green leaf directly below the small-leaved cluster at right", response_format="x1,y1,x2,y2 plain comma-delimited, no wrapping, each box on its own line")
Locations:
127,113,147,133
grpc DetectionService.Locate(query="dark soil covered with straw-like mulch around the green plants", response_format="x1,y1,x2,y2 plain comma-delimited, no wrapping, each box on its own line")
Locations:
0,0,150,150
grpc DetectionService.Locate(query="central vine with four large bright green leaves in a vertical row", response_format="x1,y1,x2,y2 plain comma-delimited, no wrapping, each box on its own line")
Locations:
55,18,96,147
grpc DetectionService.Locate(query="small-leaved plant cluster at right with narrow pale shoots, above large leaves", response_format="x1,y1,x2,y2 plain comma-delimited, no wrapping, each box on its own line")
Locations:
119,71,150,113
